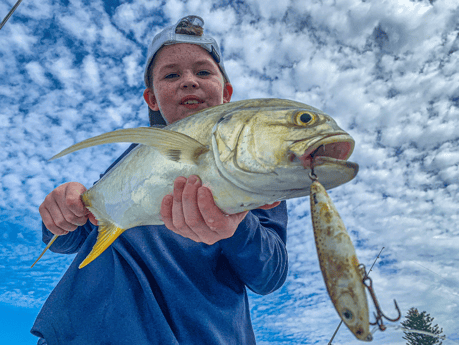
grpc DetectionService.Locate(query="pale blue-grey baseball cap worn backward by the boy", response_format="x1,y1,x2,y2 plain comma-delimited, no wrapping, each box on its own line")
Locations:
144,15,229,86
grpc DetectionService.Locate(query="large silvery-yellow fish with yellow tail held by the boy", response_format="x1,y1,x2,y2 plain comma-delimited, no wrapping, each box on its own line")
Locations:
32,98,358,268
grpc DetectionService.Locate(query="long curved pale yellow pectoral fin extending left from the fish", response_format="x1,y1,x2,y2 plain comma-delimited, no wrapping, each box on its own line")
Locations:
50,127,209,164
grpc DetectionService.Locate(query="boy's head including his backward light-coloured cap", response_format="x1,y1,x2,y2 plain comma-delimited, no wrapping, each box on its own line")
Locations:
144,16,232,124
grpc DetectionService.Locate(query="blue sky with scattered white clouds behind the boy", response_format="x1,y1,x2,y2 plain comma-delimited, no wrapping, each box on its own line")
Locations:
0,0,459,345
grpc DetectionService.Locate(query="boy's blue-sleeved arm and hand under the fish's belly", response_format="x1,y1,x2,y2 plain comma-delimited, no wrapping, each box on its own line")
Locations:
161,175,288,294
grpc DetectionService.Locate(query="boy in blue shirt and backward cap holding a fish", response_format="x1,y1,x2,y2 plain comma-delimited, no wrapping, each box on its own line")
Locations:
32,16,287,345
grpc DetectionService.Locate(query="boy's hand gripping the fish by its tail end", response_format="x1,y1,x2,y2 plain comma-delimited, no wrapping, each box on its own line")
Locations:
38,182,97,235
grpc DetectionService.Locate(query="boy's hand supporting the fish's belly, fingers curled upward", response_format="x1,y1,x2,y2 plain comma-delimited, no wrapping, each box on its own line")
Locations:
160,175,280,245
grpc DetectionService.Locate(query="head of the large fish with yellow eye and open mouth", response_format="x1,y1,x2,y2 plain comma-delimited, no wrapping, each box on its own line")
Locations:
213,99,358,199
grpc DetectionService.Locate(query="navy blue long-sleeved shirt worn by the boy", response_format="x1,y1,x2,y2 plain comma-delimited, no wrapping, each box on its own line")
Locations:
31,145,288,345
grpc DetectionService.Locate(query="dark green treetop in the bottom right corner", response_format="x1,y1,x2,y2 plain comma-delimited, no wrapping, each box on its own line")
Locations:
402,308,443,345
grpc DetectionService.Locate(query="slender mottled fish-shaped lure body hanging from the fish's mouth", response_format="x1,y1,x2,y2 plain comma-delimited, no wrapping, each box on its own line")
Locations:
310,176,373,341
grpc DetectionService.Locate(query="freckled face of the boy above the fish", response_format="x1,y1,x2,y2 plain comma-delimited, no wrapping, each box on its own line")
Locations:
144,43,233,123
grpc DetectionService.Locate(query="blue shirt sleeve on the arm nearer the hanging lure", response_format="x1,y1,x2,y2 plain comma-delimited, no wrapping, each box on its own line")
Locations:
219,201,288,295
